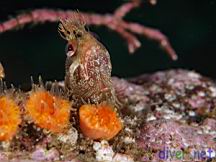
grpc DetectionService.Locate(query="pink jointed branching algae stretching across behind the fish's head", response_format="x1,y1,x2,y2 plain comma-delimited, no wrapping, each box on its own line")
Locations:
0,0,177,60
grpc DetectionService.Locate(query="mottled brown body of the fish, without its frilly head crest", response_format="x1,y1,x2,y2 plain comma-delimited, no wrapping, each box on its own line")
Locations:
60,19,117,104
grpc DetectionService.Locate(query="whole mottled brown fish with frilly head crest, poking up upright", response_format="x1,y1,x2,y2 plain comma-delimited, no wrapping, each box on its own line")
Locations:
58,18,120,105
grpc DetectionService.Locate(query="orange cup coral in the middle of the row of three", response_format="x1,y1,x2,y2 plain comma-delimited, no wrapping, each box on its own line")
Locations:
25,90,71,133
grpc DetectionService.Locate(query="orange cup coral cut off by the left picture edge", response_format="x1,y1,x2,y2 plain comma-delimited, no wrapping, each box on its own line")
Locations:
0,96,21,141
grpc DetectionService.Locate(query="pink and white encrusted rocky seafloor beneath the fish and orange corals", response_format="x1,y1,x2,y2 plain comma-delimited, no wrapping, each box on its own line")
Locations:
0,70,216,162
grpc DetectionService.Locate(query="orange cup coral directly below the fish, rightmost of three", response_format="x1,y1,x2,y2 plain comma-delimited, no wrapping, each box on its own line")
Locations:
79,103,122,140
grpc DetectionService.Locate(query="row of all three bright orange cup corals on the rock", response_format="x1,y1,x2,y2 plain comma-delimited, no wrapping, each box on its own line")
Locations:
0,89,122,141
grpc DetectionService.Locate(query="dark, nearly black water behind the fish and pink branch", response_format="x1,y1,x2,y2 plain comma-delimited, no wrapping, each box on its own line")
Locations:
0,0,216,88
